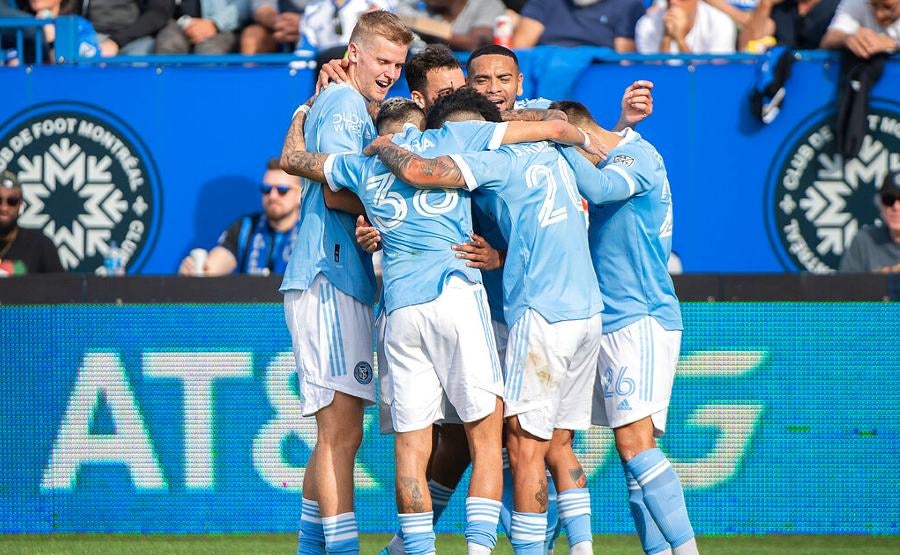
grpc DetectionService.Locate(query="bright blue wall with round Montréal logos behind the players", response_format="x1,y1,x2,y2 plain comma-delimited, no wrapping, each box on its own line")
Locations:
0,49,900,274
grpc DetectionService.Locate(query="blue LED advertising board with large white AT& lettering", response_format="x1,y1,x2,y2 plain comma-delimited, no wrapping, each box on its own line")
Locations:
0,300,900,534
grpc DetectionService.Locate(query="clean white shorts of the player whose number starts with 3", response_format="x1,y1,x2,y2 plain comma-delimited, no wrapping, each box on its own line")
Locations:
384,276,503,432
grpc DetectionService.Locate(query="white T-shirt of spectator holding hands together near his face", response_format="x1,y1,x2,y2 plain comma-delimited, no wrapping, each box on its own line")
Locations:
634,0,736,54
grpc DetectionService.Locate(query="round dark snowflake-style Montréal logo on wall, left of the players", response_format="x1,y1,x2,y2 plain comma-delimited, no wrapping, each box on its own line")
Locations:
0,103,162,273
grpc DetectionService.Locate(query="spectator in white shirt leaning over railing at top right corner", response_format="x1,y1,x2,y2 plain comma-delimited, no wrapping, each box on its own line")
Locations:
821,0,900,58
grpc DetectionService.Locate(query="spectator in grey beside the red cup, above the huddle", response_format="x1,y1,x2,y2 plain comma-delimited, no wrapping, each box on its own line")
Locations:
403,0,506,51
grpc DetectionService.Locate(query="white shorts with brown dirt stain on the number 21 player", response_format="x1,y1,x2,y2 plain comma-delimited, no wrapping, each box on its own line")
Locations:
503,309,602,440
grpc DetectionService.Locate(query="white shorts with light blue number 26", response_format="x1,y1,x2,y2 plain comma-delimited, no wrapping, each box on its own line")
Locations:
591,316,681,437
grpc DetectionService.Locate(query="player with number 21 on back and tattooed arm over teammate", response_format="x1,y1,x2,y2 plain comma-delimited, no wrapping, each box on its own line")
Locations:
368,117,602,554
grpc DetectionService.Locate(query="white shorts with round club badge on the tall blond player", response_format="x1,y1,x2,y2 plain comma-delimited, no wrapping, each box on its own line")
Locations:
284,274,375,416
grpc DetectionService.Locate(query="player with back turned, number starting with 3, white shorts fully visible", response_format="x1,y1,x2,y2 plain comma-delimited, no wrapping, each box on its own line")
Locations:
286,90,600,553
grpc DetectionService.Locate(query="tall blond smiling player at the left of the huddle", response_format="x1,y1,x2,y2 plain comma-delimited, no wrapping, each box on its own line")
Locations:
281,11,413,553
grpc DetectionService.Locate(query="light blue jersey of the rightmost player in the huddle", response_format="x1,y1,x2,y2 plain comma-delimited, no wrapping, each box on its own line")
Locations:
562,129,682,333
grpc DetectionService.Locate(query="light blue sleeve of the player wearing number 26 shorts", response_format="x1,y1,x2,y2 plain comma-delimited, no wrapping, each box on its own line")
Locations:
559,147,647,204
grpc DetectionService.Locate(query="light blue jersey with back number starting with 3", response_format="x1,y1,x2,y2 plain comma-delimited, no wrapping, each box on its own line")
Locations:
325,122,505,314
